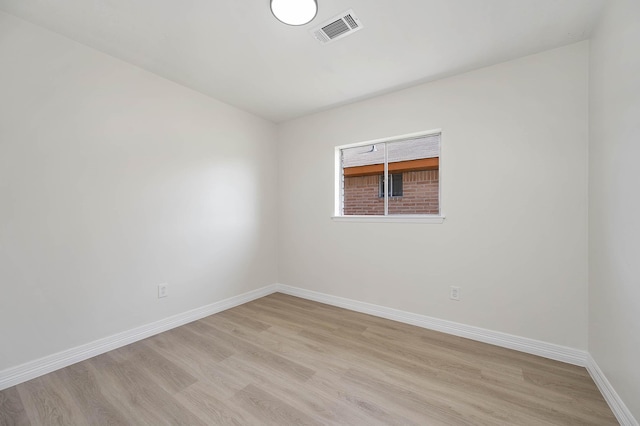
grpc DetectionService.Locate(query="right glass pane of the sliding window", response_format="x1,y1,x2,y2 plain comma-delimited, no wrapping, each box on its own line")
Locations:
387,134,440,215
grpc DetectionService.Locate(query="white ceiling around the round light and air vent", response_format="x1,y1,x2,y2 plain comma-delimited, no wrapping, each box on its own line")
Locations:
0,0,604,122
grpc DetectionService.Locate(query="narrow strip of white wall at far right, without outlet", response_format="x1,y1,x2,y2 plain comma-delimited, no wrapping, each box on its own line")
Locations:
589,0,640,419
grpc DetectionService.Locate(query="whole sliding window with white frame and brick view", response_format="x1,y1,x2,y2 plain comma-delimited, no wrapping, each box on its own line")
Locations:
335,132,442,223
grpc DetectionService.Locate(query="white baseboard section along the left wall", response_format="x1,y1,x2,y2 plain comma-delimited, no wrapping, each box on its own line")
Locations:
0,284,279,390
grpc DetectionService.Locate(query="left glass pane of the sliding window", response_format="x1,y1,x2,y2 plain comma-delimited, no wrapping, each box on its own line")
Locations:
341,143,385,216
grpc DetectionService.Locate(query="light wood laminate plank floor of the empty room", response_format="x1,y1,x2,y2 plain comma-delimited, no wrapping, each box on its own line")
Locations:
0,293,618,426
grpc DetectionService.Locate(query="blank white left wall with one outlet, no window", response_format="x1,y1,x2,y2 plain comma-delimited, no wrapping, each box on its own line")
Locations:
0,13,277,370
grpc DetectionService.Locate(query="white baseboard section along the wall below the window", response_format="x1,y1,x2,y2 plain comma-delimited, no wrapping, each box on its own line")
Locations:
277,284,587,367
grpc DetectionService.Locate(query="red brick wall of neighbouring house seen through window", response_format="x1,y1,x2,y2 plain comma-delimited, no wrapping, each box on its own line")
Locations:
344,170,440,215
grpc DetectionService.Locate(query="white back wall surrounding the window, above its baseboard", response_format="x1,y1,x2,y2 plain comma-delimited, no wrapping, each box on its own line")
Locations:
278,42,588,349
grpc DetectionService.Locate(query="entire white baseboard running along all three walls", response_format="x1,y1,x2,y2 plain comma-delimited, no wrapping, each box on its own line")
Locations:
5,284,640,426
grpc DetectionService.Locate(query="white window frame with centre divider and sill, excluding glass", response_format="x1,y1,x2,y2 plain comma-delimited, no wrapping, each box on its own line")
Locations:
331,129,445,224
